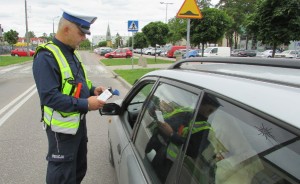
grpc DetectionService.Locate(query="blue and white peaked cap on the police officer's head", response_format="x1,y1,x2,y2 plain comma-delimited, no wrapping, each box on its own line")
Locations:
62,9,97,35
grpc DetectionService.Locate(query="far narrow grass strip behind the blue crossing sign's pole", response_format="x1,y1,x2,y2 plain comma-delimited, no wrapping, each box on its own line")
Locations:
101,58,174,66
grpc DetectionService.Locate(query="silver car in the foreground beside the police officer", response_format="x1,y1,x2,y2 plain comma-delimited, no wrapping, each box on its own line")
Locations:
100,57,300,184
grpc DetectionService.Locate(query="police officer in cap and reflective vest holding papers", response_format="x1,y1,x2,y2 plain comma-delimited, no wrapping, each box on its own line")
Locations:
33,10,105,184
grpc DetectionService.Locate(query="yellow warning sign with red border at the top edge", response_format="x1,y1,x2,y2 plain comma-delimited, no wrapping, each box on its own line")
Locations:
176,0,202,19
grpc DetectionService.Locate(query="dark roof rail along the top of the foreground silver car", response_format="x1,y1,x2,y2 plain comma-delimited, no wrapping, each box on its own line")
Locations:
168,57,300,69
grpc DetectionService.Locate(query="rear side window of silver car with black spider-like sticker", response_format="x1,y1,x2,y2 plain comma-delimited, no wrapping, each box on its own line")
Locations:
179,95,300,184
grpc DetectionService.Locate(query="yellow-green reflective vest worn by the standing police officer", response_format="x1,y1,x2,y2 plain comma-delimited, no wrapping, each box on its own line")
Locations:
36,41,92,135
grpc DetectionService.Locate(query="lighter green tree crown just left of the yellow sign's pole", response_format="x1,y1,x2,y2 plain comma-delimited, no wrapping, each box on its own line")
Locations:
168,17,187,45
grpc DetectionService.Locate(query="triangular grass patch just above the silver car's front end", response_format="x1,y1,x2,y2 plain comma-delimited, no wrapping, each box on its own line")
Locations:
114,68,158,85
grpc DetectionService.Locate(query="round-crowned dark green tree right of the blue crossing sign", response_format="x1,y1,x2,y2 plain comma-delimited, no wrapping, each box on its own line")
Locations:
142,21,169,47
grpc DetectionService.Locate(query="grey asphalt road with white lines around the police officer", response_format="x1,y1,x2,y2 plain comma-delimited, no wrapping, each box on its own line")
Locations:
0,51,128,184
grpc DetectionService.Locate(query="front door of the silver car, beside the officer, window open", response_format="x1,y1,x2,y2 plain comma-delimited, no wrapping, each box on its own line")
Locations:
109,78,156,184
